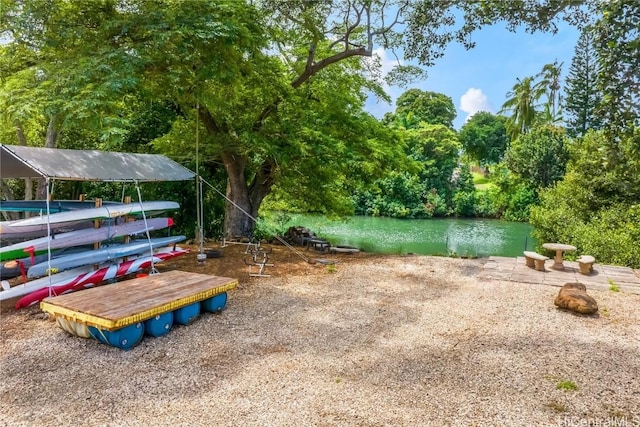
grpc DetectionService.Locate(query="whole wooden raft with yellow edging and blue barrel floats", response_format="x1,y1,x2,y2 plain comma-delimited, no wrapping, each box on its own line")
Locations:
40,270,238,350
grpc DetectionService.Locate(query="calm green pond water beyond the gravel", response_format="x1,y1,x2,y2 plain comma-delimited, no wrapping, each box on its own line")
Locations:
287,215,537,257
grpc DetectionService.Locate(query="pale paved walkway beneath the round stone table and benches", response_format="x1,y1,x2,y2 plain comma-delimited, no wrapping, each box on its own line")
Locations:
480,256,640,294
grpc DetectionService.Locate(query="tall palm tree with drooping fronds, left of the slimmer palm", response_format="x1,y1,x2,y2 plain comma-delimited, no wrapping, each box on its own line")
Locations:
499,77,545,140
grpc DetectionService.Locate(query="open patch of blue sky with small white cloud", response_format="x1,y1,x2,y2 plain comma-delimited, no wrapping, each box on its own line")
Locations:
366,24,580,129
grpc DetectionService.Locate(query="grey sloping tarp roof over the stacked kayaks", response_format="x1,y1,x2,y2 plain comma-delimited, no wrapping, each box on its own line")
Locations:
0,144,195,182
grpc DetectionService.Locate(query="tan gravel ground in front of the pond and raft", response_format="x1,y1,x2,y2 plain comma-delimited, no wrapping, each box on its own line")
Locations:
0,252,640,427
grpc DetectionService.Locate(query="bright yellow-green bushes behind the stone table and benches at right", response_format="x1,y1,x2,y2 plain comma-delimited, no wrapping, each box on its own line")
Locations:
531,131,640,268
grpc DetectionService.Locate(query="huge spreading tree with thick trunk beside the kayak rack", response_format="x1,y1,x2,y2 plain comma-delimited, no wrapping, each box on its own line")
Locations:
0,0,582,235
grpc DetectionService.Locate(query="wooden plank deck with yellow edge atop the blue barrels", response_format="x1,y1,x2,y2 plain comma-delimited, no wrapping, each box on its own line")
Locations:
40,270,238,331
